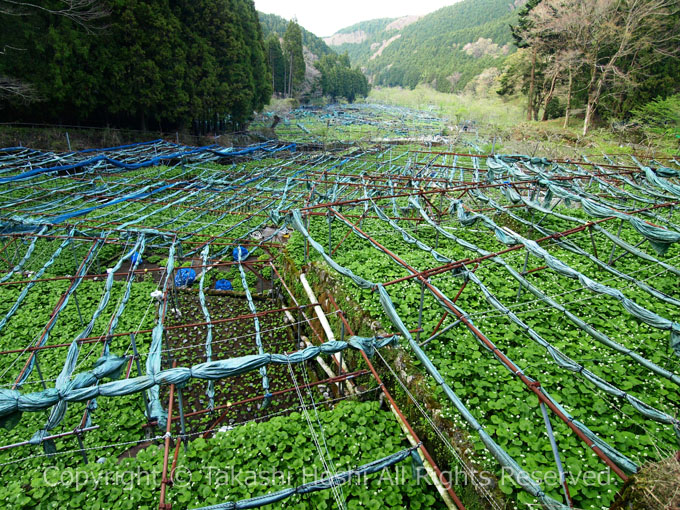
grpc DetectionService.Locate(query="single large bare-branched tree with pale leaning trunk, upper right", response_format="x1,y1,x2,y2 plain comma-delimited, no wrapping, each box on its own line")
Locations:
527,0,680,135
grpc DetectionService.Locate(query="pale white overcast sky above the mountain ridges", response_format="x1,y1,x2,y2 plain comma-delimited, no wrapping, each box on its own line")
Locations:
255,0,457,37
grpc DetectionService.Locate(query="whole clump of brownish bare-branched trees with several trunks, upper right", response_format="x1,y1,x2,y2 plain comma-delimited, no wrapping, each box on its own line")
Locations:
499,0,680,134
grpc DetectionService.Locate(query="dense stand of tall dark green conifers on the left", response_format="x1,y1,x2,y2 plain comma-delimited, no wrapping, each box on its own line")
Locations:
0,0,272,133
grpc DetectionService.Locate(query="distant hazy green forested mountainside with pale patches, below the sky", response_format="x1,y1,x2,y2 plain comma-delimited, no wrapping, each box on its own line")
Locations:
326,0,525,92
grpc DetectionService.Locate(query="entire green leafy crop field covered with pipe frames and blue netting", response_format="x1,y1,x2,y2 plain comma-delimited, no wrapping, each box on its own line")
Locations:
0,105,680,509
